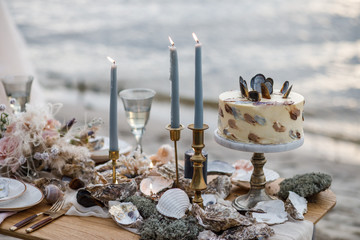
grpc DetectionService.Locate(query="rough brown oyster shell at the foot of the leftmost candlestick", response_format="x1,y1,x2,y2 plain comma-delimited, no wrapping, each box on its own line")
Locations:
86,179,137,203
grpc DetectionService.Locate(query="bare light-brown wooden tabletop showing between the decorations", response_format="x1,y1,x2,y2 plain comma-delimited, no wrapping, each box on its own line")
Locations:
0,183,336,240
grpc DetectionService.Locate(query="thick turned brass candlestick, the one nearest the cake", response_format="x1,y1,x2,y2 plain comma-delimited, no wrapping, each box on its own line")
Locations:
188,124,209,208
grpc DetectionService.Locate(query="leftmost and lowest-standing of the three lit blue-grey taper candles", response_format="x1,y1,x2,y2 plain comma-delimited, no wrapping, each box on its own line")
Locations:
108,57,119,151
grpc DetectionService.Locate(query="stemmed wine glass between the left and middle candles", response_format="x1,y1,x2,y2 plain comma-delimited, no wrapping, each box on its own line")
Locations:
119,88,156,152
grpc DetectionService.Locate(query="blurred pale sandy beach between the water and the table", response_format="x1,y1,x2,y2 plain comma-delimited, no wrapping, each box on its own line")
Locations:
38,90,360,240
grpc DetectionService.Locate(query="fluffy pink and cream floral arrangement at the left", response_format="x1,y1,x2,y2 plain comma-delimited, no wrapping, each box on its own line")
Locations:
0,104,94,181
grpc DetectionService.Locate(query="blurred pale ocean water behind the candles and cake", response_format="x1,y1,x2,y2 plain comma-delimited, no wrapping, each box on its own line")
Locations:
6,0,360,144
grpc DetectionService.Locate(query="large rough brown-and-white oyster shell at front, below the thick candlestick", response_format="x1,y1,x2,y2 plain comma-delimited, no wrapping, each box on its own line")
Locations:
192,203,252,232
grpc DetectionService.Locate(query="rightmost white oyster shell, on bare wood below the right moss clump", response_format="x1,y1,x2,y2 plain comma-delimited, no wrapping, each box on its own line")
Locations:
285,191,307,220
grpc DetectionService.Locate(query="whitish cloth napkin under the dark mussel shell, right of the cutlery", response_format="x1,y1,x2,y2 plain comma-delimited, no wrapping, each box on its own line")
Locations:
65,190,110,218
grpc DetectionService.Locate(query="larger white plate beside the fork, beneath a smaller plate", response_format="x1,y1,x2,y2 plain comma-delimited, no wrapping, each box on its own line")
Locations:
0,183,44,211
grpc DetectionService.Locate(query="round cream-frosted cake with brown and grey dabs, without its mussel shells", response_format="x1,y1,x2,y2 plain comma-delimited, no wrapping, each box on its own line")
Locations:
218,89,305,144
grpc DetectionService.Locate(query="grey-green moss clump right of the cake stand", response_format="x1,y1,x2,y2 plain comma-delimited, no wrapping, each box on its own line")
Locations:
278,173,332,200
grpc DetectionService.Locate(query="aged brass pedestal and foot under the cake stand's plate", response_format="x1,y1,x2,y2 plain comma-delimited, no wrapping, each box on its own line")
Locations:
232,153,273,211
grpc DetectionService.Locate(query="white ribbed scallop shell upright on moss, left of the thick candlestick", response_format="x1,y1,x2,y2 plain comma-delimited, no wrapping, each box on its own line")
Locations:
156,188,190,219
